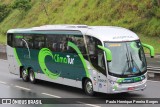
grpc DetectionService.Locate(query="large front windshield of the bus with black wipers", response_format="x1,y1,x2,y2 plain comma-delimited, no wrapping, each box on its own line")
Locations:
105,40,147,77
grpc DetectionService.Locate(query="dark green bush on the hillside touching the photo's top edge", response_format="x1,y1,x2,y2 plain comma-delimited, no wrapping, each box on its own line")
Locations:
12,0,31,11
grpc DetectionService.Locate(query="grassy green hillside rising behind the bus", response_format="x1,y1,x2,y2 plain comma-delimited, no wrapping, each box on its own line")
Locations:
0,0,160,53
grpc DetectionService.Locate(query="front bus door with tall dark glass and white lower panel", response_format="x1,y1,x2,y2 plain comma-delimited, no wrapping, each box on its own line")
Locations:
86,36,107,92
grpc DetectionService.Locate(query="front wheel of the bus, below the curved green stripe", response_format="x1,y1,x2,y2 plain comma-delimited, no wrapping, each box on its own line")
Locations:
84,79,94,96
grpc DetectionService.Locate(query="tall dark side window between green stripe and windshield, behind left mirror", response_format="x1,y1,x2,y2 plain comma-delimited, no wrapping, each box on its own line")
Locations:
86,36,106,75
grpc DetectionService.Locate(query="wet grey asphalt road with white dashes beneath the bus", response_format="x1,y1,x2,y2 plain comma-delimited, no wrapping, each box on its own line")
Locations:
0,60,160,107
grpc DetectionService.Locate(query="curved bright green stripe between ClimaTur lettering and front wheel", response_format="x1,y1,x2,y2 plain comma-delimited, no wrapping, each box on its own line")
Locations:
68,42,89,78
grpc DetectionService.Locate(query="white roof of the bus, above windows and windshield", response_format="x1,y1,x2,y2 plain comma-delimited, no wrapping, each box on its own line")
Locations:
7,25,139,41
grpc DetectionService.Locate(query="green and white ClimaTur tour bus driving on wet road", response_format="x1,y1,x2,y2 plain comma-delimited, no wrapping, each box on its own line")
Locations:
7,25,154,95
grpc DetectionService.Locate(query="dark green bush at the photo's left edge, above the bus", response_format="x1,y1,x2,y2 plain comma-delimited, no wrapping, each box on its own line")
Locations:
0,4,11,22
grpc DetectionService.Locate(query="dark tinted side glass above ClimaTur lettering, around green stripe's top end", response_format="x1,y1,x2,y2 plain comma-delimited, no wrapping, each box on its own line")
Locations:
47,35,86,54
